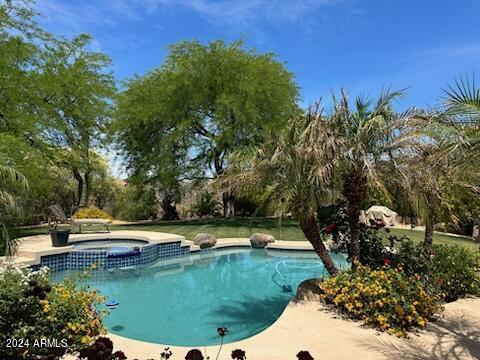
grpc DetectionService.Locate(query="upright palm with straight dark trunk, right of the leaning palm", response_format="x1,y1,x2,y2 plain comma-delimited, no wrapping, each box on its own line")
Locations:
328,90,416,260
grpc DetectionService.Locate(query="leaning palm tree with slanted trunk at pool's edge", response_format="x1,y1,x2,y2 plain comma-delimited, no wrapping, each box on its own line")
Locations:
219,105,338,274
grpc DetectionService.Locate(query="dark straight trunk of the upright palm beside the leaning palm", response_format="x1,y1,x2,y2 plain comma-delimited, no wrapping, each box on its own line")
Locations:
343,174,367,267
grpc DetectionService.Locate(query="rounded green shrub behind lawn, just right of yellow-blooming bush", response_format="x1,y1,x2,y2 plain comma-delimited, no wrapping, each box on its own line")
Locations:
115,184,157,221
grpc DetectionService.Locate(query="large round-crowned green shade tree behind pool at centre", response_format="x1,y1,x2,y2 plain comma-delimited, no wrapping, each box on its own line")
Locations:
114,40,298,216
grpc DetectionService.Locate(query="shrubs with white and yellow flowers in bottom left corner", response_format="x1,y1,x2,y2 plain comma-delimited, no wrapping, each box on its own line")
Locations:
0,265,105,359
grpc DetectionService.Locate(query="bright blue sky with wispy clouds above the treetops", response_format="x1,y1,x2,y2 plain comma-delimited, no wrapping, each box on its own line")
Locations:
36,0,480,107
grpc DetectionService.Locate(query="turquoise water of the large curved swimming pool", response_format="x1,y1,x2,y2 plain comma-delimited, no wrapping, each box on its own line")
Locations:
54,248,347,346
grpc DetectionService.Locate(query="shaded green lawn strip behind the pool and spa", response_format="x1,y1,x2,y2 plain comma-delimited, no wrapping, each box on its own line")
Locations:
16,218,479,250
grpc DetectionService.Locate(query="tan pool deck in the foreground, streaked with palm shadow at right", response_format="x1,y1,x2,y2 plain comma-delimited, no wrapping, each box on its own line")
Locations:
108,298,480,360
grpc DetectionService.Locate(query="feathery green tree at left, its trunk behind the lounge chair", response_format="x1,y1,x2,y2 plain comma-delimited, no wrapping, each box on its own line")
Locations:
38,35,115,208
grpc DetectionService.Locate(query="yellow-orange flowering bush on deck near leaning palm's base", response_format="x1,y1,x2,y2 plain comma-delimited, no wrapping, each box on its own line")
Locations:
320,264,441,337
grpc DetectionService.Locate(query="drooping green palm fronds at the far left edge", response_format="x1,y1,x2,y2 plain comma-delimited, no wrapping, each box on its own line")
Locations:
0,164,28,256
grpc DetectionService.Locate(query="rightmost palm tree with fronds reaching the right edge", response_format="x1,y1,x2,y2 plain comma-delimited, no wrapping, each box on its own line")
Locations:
397,78,480,256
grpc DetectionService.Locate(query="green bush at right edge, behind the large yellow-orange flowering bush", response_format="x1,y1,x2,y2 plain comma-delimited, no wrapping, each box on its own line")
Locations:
396,241,480,302
